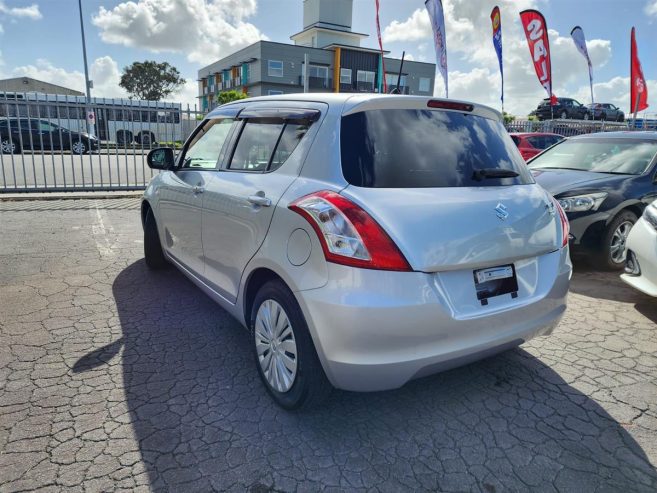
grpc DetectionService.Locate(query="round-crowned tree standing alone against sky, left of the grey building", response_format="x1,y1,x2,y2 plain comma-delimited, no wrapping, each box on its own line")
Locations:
119,60,185,101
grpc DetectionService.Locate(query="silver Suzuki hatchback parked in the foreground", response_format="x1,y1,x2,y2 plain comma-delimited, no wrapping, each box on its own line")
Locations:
142,94,572,409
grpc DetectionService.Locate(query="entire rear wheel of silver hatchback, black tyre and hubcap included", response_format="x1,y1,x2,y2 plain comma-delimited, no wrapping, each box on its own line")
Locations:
249,280,332,410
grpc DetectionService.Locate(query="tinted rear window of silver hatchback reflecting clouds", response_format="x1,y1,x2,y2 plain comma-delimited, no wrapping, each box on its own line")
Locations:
340,109,534,188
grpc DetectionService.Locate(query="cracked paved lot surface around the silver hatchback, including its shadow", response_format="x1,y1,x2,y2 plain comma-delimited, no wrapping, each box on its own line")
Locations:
0,199,657,493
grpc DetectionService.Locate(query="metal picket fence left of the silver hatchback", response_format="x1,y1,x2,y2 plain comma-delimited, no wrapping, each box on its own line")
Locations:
0,94,204,193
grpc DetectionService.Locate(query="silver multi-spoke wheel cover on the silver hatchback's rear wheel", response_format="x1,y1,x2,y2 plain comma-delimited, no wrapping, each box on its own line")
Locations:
254,299,297,393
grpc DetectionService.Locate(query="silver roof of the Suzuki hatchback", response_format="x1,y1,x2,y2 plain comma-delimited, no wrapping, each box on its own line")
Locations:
213,92,502,121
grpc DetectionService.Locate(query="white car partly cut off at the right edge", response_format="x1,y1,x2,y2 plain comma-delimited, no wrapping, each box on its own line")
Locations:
621,200,657,296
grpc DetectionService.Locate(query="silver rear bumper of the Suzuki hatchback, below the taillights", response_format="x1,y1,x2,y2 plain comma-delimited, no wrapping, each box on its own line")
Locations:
296,248,571,391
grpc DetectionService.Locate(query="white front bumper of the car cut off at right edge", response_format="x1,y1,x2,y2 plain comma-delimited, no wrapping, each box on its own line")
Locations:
621,219,657,296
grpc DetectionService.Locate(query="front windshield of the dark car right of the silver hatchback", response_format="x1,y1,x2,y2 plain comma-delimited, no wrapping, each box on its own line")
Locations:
529,139,657,175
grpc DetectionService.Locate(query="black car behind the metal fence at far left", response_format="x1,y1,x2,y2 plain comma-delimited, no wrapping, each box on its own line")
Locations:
0,118,100,154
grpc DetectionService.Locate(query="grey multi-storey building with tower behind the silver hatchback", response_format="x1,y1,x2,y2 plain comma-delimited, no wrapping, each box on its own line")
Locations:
198,0,436,110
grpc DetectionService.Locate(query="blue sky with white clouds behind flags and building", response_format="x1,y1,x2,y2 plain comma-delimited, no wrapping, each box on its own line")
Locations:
0,0,657,116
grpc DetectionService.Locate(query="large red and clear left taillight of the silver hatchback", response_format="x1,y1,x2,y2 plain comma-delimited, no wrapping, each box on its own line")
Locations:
289,191,411,271
